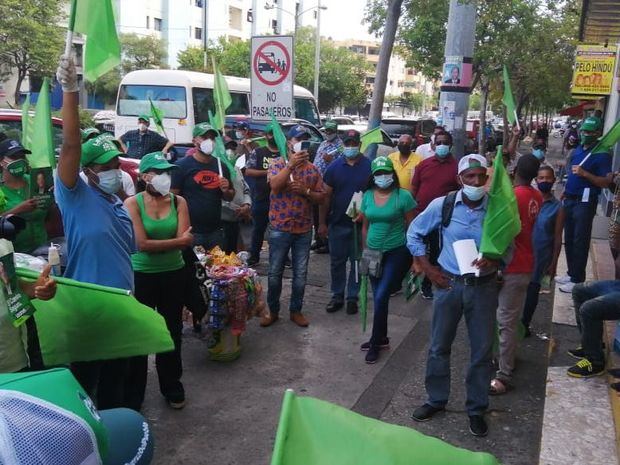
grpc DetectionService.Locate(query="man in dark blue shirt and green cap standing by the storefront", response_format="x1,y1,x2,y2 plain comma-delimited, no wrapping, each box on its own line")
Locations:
556,116,612,293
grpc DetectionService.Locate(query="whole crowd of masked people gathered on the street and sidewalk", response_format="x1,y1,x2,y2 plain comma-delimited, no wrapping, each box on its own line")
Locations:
0,53,620,446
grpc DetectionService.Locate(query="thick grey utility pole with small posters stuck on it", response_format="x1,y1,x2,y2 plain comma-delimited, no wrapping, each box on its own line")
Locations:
439,0,484,159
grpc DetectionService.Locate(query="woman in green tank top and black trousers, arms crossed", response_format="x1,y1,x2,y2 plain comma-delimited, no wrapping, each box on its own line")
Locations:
125,152,193,410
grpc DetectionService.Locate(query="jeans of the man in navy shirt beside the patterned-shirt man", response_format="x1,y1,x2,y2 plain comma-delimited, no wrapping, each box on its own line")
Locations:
328,224,361,302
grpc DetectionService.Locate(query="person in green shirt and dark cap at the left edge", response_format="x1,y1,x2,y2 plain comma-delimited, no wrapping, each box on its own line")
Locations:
0,141,53,253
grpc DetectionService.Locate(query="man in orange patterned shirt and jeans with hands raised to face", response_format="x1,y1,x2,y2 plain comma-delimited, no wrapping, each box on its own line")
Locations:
260,147,325,327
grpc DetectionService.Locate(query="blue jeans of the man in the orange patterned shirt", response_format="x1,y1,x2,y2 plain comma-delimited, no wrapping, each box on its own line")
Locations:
267,229,312,315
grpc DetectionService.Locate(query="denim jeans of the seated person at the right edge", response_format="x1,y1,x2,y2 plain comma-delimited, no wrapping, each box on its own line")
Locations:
573,280,620,363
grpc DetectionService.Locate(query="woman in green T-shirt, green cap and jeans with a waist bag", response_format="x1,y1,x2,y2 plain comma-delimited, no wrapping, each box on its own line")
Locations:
361,157,416,363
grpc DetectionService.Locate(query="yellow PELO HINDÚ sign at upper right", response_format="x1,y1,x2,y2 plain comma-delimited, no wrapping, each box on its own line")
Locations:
572,45,616,95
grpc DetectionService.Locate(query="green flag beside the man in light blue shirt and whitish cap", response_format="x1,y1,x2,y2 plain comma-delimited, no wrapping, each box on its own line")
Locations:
480,145,521,259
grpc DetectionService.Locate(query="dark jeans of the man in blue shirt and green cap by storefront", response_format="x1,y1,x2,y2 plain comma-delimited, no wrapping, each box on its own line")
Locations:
563,197,597,283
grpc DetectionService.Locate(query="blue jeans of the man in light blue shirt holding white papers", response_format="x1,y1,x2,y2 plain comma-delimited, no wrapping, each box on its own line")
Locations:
426,280,499,415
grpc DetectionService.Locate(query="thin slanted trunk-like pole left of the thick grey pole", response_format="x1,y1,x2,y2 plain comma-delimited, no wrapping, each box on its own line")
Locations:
367,0,403,160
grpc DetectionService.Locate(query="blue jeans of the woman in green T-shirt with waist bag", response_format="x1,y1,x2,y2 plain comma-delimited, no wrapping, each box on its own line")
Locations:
370,245,413,346
